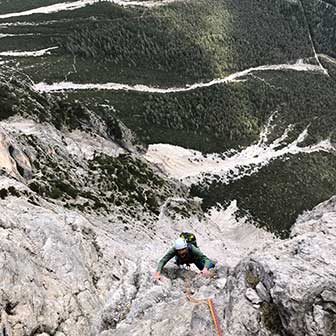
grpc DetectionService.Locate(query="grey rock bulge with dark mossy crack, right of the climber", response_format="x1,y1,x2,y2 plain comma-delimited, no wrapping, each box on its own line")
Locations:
225,197,336,336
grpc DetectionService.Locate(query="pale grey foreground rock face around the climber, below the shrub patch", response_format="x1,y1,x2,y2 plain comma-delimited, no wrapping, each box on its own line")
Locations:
0,142,336,336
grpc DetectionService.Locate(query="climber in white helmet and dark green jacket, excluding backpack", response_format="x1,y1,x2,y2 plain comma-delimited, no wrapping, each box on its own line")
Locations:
154,238,215,282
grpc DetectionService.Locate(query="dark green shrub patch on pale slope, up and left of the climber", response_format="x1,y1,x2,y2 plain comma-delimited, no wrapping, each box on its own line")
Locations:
27,139,174,216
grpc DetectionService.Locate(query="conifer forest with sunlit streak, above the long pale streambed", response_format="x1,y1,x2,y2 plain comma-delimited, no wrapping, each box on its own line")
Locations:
56,0,311,82
